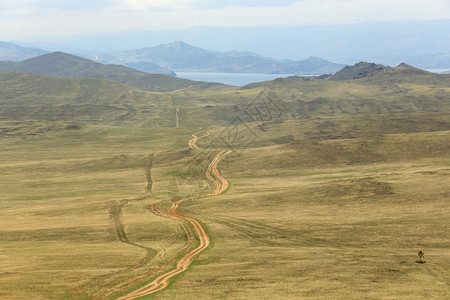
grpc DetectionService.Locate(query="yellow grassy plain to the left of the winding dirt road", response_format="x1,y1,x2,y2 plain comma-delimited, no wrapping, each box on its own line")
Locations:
0,126,193,299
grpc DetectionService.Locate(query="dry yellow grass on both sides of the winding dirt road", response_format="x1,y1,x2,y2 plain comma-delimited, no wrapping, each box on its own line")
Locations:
0,119,450,299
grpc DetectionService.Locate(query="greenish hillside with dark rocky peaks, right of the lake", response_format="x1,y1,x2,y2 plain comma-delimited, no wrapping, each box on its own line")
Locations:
243,65,450,117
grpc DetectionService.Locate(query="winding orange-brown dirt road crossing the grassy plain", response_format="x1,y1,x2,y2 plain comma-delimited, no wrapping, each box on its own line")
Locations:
117,140,231,300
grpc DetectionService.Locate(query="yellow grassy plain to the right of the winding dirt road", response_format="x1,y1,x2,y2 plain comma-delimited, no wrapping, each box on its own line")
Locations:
155,117,450,299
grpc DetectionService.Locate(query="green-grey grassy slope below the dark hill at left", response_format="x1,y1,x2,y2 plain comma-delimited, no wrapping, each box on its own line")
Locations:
0,72,183,127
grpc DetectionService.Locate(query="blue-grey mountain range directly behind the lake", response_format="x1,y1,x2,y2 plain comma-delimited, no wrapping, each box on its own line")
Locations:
99,42,344,75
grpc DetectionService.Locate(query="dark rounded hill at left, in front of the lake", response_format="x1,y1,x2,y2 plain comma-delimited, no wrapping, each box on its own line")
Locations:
0,52,222,92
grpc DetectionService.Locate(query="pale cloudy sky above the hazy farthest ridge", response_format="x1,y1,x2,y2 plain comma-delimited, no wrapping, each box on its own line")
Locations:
0,0,450,40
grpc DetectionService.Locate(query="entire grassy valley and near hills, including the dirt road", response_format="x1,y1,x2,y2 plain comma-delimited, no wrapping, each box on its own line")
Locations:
0,53,450,299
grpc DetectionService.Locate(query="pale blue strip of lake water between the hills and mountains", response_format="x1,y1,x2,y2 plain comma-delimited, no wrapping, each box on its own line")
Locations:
176,72,298,86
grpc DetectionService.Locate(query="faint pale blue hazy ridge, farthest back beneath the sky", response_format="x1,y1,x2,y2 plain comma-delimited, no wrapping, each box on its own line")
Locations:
13,20,450,69
